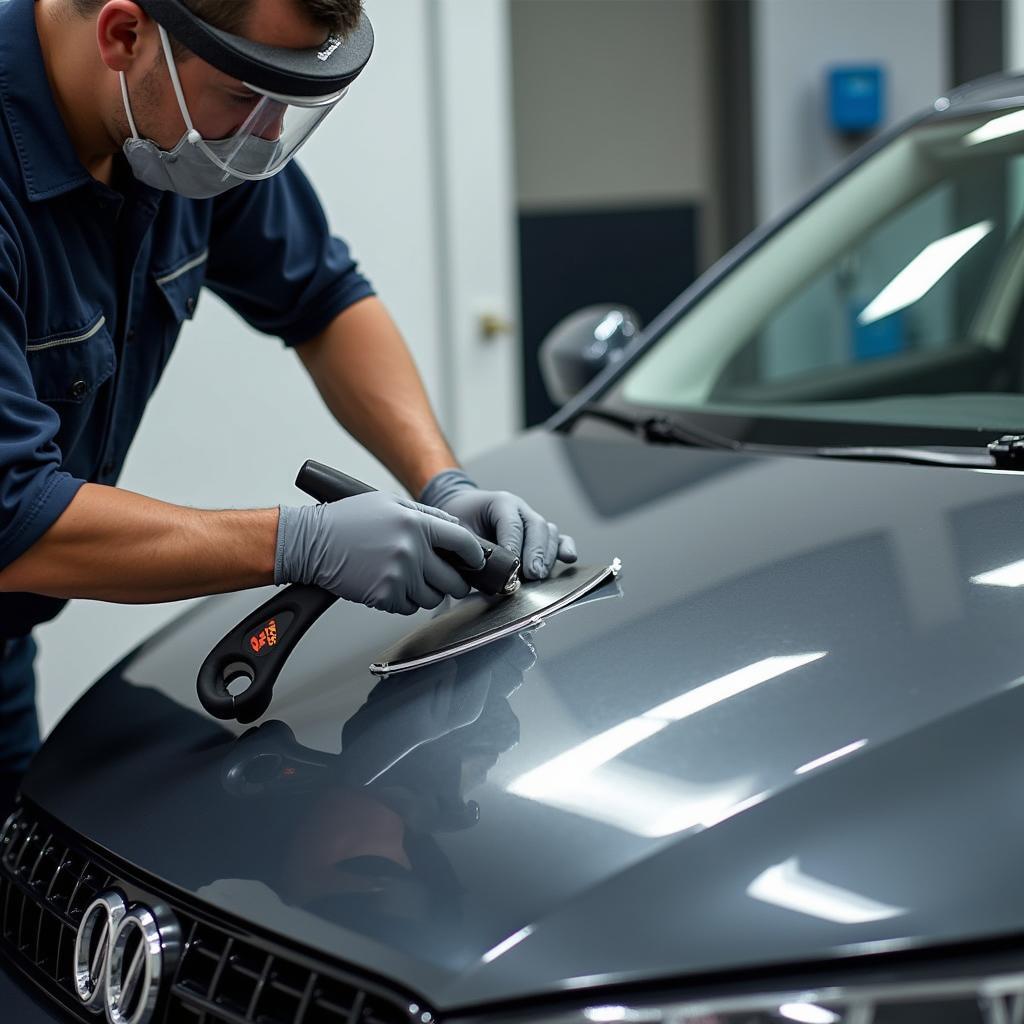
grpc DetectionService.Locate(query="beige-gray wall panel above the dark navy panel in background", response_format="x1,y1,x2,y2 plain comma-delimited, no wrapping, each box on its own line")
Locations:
512,0,715,253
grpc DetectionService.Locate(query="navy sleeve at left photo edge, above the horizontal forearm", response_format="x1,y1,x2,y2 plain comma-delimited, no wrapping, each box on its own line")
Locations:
0,217,85,568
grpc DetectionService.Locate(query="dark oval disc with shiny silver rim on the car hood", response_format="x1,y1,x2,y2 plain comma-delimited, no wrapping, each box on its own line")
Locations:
370,558,622,676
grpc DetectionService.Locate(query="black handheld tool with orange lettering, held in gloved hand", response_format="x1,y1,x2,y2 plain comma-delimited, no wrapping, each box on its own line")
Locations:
196,460,520,724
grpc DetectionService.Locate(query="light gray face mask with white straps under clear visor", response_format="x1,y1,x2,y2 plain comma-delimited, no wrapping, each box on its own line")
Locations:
120,26,331,199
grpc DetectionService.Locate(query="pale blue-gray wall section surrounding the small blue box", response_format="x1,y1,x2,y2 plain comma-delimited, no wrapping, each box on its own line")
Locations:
752,0,950,221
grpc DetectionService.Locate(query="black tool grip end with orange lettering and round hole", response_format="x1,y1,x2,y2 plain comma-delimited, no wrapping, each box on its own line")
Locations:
196,584,337,723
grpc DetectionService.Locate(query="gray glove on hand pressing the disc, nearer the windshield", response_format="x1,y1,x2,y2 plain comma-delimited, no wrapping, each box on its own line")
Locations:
420,469,577,580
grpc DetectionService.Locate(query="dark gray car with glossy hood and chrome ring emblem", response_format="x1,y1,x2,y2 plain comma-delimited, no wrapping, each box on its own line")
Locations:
6,77,1024,1024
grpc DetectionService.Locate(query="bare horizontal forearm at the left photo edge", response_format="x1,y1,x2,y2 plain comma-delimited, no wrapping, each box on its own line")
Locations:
0,483,278,603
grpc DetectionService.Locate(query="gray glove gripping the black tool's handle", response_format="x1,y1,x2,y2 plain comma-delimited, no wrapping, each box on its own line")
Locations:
273,490,484,615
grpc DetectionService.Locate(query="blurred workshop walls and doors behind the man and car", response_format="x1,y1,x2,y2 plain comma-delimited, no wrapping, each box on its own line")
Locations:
37,0,1024,729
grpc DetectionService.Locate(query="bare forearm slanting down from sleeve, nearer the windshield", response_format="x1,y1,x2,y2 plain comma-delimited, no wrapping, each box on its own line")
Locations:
296,298,457,497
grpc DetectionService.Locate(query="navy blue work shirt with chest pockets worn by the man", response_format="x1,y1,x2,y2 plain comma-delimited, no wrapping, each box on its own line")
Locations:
0,0,373,637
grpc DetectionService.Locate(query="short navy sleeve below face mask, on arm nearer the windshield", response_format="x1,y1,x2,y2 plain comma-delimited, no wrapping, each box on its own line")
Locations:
206,161,374,345
